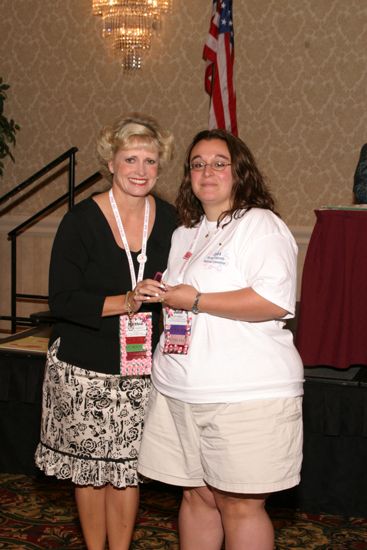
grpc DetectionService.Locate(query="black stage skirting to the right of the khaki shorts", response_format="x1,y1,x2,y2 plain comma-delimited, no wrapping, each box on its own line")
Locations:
269,374,367,518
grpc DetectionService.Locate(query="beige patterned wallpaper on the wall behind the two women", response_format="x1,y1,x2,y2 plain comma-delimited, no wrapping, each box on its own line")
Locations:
0,0,367,226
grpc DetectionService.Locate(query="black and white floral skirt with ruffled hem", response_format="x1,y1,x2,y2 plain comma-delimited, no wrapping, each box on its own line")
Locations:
35,340,151,488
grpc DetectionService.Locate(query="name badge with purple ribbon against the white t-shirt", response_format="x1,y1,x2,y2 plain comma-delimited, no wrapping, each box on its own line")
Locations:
163,307,192,355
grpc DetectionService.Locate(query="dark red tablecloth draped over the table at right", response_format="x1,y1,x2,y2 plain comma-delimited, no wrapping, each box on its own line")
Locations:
296,210,367,369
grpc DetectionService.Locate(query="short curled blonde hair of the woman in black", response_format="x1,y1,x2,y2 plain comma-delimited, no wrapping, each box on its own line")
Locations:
97,113,173,176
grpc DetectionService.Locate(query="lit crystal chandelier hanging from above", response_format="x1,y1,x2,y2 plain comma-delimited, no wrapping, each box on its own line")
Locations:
92,0,172,70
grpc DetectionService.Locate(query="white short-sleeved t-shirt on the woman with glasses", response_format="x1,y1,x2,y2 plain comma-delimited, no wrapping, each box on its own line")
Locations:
152,208,303,403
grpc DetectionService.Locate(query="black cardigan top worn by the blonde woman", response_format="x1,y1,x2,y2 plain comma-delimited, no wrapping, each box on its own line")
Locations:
49,197,177,374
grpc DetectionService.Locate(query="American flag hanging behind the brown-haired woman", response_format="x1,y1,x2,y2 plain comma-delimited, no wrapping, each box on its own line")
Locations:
203,0,237,135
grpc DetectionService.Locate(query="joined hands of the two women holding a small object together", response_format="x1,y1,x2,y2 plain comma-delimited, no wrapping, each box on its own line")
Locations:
133,279,198,311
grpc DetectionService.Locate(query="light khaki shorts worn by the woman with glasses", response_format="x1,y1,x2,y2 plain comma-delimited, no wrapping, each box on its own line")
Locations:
138,388,303,494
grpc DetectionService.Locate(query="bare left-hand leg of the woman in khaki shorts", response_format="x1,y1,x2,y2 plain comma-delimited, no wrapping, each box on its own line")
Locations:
179,487,223,550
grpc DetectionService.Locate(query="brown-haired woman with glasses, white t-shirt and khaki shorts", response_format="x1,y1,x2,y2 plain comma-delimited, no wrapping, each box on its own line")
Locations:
138,130,303,550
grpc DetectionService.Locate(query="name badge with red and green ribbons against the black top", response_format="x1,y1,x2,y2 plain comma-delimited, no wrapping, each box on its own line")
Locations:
120,312,152,376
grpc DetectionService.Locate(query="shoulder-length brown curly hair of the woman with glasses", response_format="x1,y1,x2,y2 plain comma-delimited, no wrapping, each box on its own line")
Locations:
176,129,278,227
